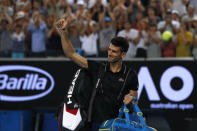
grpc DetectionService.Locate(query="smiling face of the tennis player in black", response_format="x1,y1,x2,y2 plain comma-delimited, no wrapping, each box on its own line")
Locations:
108,44,126,63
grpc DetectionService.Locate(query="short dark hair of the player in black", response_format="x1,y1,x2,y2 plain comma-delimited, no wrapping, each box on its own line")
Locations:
111,37,129,52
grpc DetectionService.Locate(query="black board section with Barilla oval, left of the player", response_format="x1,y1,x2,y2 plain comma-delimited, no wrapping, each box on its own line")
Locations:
0,59,78,109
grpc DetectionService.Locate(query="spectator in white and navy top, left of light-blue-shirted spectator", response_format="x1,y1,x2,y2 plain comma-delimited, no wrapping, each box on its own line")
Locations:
12,24,25,58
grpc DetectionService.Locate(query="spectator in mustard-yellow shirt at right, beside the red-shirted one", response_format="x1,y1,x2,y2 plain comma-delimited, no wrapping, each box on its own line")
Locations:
175,22,193,57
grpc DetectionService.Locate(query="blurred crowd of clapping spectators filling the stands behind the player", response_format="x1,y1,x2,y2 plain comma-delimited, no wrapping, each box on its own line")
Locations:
0,0,197,58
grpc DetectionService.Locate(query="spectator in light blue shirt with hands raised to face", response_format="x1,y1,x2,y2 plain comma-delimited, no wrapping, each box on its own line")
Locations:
28,11,47,57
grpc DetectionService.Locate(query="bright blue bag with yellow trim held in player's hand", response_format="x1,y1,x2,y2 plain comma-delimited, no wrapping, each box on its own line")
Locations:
99,102,157,131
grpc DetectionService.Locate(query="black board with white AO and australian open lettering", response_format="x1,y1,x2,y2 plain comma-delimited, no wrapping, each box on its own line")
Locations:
125,60,197,117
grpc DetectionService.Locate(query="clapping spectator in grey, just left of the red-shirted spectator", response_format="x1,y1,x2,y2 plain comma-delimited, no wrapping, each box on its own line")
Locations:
147,23,161,58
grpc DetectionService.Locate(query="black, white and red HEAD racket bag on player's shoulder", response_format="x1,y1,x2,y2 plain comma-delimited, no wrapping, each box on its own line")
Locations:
58,68,92,131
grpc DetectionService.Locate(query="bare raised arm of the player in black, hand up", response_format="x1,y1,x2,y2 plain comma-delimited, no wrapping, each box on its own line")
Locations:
55,17,88,69
